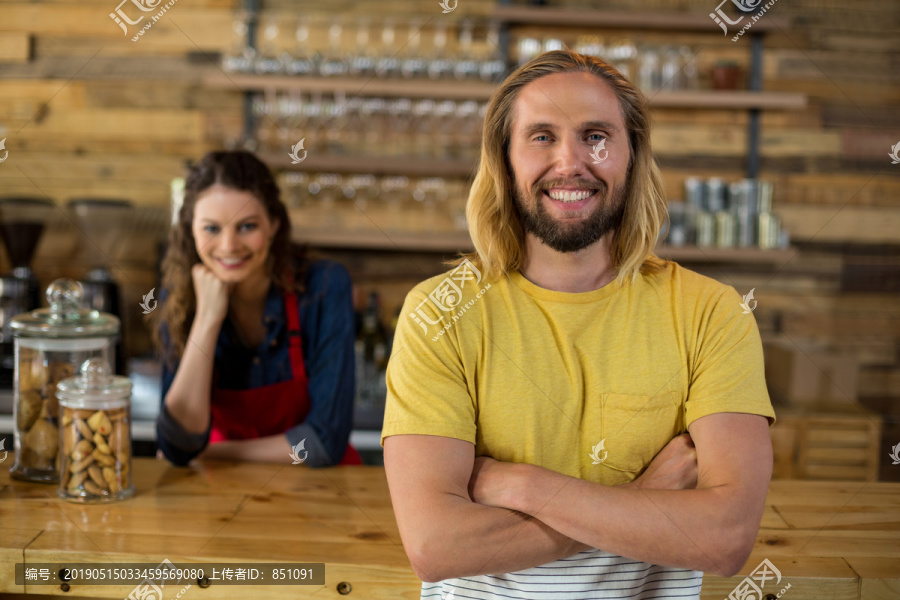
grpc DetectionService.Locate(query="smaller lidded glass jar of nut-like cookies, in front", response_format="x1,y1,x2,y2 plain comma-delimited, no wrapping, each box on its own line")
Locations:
56,358,134,502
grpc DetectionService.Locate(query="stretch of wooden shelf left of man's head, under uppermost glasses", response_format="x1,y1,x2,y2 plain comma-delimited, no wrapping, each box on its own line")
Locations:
203,73,497,100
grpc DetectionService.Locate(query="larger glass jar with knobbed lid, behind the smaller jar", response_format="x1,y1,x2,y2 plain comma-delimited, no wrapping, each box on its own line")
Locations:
10,279,119,483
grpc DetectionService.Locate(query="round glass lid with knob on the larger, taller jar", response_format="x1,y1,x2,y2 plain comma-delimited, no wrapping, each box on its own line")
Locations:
9,279,119,338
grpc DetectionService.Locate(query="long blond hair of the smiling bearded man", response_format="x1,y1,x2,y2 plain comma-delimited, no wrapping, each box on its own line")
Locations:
460,50,668,285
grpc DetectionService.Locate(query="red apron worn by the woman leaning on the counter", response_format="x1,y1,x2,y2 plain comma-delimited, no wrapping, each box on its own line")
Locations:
209,278,362,465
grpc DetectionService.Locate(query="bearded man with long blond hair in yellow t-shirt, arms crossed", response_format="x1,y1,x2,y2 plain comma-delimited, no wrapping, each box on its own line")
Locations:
382,51,775,599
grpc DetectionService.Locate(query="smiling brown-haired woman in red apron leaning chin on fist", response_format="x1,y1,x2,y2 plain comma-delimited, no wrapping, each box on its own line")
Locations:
151,152,361,467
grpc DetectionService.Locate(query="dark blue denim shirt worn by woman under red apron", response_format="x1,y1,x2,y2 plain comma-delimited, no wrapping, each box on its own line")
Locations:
156,260,356,467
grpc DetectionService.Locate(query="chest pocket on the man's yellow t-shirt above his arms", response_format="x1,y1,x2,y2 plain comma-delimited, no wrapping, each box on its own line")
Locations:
601,391,683,473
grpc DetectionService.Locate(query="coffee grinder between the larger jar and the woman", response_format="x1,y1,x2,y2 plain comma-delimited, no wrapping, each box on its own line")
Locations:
68,198,134,374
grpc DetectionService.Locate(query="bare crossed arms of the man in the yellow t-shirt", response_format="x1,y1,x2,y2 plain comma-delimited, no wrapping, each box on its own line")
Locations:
384,413,772,581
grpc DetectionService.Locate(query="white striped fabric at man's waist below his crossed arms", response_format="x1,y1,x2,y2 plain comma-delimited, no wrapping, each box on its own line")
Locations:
420,550,703,600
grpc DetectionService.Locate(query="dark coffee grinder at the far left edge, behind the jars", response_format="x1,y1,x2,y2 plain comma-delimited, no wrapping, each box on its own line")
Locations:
0,196,55,389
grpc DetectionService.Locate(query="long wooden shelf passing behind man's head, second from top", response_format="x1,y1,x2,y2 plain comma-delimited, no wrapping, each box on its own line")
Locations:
204,74,807,110
